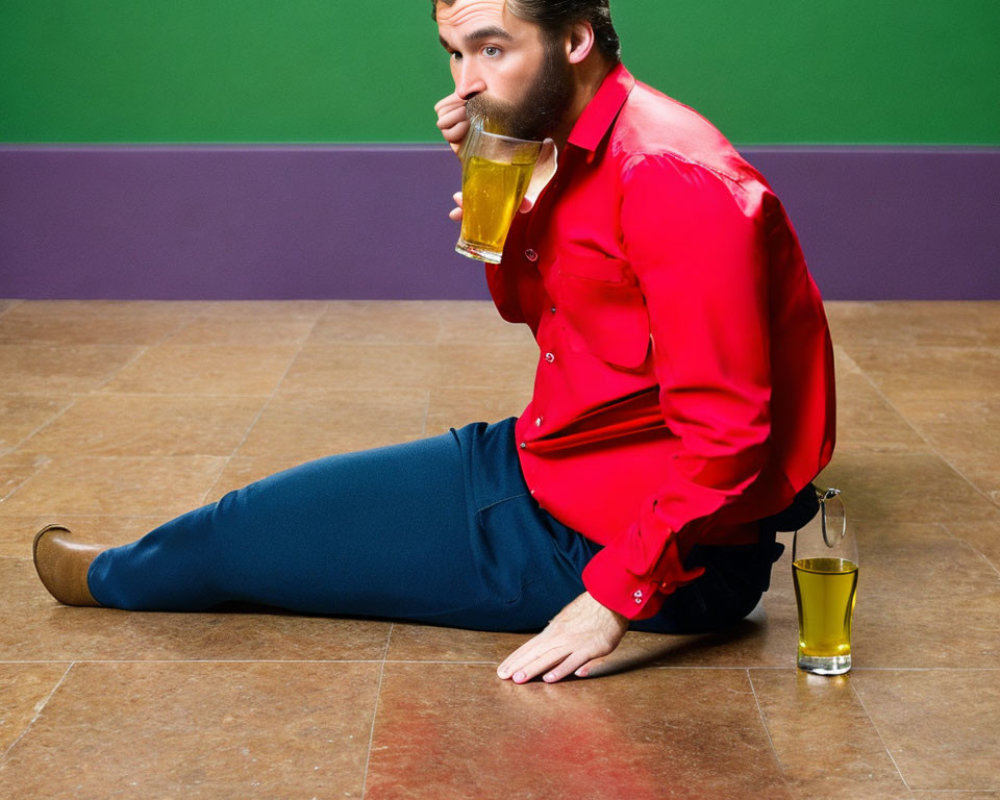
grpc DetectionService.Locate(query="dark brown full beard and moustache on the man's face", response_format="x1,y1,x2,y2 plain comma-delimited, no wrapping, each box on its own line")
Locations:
465,42,573,140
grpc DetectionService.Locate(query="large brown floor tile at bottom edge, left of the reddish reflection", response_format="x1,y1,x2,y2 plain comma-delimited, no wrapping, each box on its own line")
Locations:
0,663,377,800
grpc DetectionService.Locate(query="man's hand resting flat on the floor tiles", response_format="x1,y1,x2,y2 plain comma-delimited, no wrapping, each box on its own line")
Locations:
497,592,628,683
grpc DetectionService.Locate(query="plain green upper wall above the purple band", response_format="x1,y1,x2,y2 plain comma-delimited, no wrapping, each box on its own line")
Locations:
0,0,1000,146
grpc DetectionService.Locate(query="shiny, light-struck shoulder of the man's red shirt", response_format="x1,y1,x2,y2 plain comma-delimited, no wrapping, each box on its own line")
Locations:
611,81,753,180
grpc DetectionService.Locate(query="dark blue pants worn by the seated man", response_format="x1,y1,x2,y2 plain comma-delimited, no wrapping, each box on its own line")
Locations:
88,419,775,632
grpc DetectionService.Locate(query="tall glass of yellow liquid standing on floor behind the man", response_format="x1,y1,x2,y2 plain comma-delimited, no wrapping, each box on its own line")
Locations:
792,489,858,675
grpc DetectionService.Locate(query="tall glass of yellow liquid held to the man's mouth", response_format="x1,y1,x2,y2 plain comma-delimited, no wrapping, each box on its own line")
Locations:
455,124,542,264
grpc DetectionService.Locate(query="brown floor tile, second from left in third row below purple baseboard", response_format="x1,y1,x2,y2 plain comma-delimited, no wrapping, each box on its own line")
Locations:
20,395,264,457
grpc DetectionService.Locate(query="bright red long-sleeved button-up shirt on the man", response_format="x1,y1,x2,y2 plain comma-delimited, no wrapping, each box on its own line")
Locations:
486,65,834,619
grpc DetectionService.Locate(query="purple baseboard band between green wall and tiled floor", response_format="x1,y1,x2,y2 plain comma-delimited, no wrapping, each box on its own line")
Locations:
0,145,1000,300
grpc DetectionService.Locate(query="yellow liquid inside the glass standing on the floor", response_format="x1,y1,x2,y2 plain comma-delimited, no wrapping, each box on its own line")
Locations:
792,558,858,658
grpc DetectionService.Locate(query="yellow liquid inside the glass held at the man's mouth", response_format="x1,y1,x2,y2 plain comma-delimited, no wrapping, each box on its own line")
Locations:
462,156,535,255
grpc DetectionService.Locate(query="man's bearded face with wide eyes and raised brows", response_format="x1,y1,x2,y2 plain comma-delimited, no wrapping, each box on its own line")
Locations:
437,0,573,139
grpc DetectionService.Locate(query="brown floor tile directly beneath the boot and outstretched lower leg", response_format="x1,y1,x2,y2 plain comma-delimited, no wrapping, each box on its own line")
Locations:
0,558,391,661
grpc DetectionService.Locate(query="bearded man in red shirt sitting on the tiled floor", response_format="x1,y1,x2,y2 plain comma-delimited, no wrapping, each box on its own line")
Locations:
34,0,834,683
